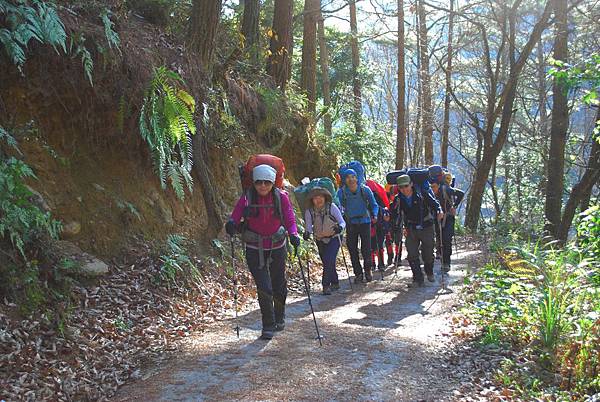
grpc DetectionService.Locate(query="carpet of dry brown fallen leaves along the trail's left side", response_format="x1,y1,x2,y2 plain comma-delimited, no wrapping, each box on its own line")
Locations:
0,242,330,401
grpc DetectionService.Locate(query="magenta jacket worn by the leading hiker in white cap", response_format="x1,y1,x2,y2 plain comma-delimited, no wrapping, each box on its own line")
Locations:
231,191,298,250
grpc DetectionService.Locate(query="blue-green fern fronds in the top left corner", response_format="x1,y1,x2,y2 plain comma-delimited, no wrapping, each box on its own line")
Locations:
0,0,67,71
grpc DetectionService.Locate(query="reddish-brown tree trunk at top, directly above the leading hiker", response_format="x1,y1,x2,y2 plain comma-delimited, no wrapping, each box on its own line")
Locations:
267,0,294,91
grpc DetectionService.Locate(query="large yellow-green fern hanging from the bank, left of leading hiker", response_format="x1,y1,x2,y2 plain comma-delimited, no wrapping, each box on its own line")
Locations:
139,67,196,200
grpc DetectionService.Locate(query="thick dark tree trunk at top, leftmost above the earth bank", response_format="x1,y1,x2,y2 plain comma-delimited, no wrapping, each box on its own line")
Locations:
188,0,222,71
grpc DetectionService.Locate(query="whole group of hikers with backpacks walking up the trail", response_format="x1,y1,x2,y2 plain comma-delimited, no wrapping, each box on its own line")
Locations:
225,154,464,339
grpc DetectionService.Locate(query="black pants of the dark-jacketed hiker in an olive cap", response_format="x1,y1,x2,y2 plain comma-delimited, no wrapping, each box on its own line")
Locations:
405,224,434,283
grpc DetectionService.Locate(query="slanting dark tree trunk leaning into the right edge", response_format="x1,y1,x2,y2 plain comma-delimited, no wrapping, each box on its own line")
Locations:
556,107,600,243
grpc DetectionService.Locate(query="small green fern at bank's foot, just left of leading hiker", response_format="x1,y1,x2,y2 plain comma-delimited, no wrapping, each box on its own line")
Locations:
157,234,200,287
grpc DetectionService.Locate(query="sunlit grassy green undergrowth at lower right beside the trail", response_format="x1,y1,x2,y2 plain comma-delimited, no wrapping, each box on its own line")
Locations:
469,207,600,399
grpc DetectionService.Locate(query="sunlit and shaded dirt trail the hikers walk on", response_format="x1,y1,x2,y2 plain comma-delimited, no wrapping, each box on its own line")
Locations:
115,243,480,401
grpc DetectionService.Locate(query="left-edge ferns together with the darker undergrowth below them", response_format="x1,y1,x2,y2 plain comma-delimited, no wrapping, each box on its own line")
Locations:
0,127,78,331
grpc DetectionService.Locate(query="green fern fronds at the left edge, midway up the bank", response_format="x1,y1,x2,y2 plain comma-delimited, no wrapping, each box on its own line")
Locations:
0,127,61,259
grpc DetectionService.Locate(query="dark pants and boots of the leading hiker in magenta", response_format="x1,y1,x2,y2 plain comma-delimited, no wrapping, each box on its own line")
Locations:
246,246,287,331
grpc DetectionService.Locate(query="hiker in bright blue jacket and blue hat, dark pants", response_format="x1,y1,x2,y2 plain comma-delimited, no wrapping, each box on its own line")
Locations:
337,169,379,283
